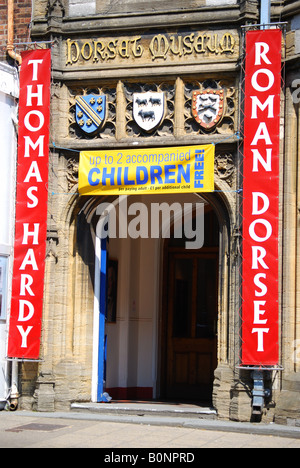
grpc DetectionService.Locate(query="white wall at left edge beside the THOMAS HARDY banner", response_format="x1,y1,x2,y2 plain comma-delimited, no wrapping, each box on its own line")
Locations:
0,63,18,401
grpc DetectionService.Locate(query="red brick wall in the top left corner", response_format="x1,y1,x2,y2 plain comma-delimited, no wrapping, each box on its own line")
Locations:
0,0,32,61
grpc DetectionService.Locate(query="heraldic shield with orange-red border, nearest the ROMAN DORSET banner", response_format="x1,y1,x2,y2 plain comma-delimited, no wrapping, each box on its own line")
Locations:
192,88,224,130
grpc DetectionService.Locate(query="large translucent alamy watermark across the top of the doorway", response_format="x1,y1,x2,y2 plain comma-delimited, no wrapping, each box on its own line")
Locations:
96,196,204,250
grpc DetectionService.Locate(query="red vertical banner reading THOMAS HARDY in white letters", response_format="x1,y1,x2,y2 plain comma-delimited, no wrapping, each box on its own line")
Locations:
8,50,51,359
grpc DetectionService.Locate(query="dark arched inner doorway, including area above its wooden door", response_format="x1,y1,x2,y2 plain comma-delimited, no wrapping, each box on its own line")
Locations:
161,204,219,403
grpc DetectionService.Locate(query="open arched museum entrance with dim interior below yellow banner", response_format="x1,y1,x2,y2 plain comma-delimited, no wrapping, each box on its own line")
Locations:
95,194,220,403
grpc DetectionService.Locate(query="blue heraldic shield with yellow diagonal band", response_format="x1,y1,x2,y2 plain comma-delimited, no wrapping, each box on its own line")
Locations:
76,94,106,134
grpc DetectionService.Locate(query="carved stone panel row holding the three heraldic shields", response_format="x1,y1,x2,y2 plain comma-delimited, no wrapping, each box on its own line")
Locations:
66,78,237,142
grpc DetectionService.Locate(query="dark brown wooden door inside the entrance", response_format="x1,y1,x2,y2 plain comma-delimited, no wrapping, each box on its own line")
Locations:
166,254,218,400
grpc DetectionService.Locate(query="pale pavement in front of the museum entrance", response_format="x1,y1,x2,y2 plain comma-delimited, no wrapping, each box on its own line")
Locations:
0,411,300,450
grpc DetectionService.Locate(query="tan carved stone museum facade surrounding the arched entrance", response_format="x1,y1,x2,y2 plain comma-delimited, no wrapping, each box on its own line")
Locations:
8,0,300,423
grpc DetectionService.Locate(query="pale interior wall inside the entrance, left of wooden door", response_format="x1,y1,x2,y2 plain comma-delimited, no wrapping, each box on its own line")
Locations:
106,197,159,394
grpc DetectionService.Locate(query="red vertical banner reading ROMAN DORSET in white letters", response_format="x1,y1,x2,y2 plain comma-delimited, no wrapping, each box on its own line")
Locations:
242,30,282,366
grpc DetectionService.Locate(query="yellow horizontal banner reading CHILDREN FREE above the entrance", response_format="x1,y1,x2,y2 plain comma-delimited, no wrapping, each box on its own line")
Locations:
79,145,215,195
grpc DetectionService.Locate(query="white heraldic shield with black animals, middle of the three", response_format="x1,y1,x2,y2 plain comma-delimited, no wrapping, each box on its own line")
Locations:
133,92,165,132
